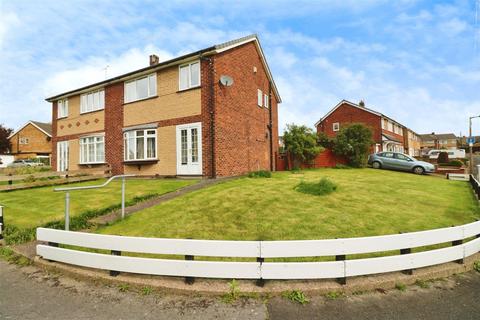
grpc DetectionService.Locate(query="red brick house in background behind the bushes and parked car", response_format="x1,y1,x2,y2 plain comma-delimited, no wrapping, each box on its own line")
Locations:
315,100,420,156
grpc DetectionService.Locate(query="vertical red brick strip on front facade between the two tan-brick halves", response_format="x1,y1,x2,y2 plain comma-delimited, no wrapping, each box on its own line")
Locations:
105,82,123,175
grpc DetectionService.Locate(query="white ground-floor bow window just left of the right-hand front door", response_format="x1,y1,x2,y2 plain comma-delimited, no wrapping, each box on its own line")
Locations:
123,129,157,161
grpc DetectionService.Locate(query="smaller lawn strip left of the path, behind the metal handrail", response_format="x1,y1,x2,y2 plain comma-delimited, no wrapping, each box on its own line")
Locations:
0,179,197,228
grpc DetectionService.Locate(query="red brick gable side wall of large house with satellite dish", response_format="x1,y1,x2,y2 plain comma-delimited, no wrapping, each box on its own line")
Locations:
210,43,278,176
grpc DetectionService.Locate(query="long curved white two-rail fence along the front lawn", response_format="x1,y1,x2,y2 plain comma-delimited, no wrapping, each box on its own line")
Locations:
37,221,480,279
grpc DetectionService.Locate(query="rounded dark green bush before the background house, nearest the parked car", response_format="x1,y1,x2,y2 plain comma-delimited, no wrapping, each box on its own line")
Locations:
333,123,373,167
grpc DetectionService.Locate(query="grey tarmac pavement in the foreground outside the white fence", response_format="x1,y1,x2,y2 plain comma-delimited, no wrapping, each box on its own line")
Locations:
0,260,480,320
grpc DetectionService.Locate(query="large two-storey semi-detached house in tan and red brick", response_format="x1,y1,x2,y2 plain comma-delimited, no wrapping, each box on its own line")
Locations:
46,35,281,177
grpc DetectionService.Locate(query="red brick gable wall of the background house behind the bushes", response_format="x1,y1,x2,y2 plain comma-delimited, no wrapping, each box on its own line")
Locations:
317,103,382,144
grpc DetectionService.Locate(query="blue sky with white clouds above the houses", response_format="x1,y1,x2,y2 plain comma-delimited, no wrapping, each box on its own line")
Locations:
0,0,480,135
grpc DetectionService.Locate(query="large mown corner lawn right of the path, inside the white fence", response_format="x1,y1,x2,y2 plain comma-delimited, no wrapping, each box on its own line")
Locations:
98,169,480,240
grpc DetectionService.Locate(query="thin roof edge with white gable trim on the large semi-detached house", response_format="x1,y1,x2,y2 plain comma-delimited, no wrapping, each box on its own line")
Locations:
45,34,282,103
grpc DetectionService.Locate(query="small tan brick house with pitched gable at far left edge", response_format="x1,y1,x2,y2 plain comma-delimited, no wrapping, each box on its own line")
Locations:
8,121,52,164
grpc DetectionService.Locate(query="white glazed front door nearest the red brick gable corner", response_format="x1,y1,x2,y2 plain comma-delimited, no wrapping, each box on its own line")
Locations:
177,122,202,175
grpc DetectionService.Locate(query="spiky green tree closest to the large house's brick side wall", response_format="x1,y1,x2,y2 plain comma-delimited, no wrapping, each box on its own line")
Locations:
283,124,323,167
